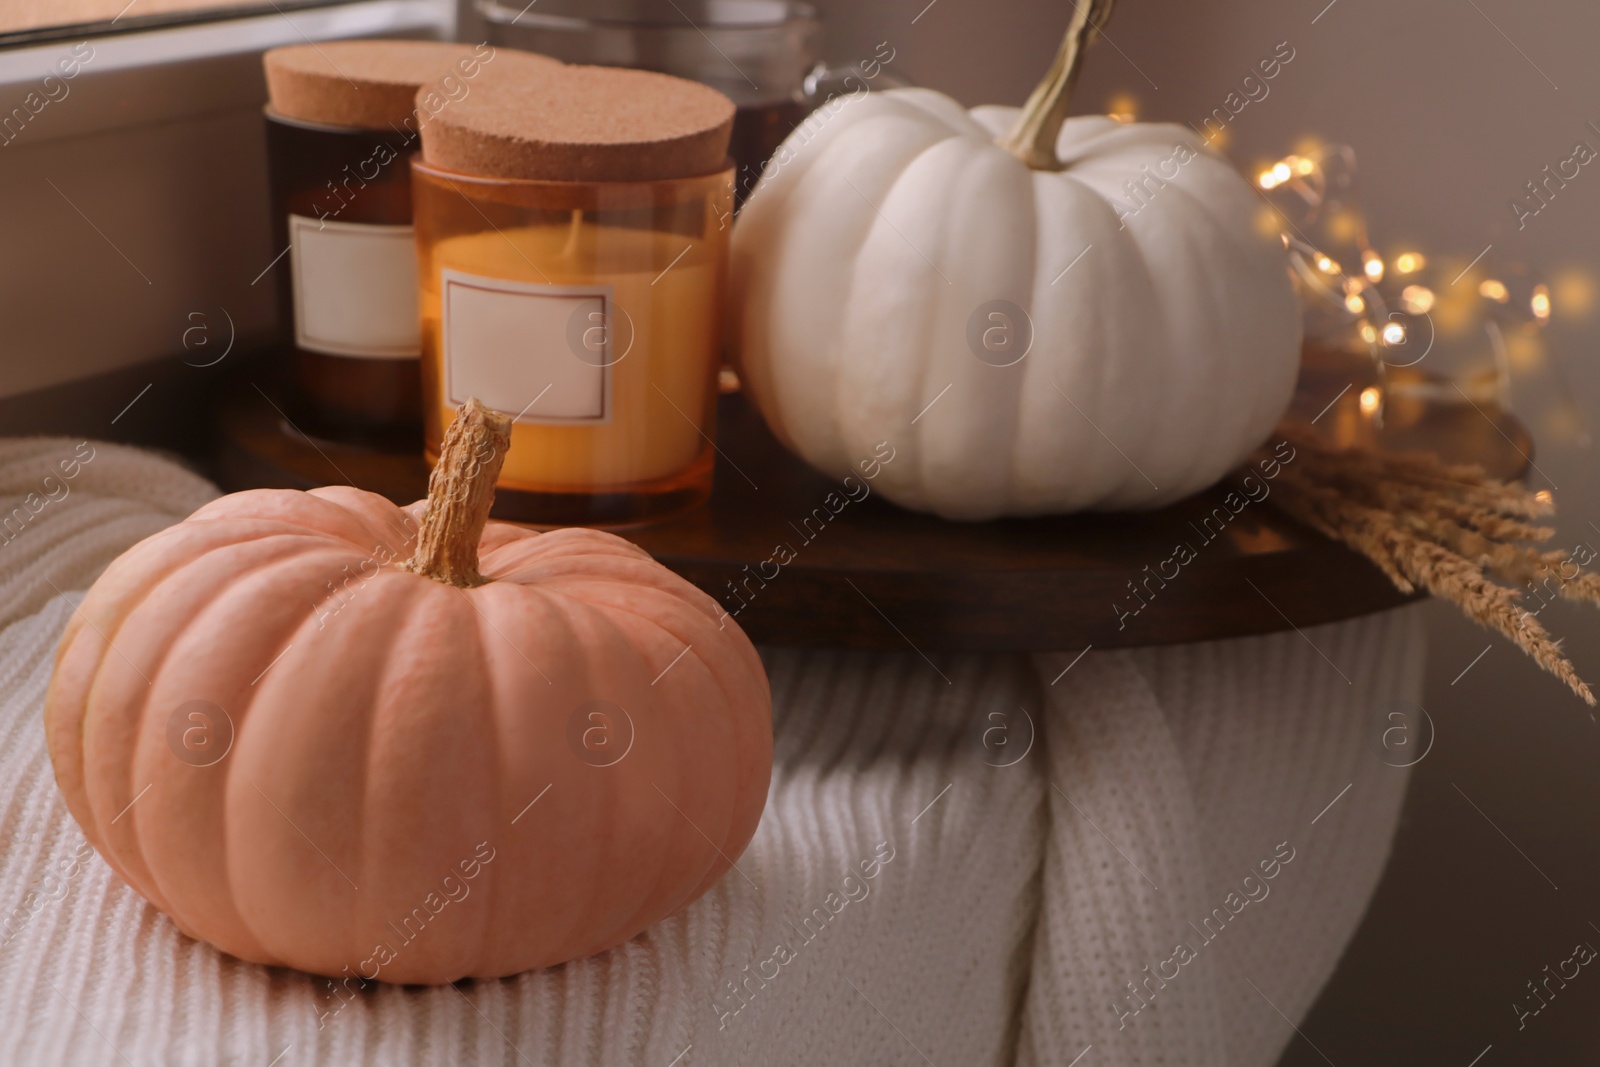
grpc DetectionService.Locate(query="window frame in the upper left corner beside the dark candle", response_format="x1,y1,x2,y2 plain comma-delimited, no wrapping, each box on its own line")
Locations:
0,0,456,397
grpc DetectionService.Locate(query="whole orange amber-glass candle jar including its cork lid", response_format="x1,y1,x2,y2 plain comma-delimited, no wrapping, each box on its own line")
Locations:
411,67,734,525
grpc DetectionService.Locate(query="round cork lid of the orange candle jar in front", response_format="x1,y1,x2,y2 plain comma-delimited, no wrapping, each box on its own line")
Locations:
422,66,734,181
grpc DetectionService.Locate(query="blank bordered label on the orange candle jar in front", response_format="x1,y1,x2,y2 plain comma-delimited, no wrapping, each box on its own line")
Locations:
440,270,611,426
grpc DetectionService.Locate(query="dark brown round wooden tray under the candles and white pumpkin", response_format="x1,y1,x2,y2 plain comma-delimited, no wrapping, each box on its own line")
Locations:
218,348,1531,654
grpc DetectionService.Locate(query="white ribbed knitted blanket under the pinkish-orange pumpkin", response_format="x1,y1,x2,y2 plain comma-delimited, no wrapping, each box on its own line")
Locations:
0,438,1422,1067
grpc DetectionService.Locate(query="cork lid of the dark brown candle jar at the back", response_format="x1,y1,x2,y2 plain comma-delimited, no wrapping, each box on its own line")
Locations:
262,40,562,130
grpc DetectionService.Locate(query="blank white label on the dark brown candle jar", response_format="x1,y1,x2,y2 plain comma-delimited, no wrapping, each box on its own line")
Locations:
290,214,422,360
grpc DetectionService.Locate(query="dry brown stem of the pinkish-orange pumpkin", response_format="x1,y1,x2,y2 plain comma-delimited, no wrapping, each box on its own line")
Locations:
400,397,510,589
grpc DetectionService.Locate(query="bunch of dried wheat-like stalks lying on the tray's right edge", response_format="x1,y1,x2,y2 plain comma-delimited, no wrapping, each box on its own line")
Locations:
1261,422,1600,707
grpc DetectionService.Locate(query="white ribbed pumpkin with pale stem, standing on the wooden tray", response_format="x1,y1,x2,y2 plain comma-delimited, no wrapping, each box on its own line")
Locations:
730,5,1301,518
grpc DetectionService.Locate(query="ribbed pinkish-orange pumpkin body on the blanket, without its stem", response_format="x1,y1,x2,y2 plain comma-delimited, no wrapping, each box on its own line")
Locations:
45,488,771,982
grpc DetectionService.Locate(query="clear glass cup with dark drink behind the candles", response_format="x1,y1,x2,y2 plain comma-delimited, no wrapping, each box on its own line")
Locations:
477,0,909,203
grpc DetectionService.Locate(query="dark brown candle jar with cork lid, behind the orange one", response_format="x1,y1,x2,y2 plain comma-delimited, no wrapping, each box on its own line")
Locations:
262,40,558,450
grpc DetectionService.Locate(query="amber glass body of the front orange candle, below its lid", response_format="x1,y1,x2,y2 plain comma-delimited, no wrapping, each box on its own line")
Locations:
411,157,734,525
